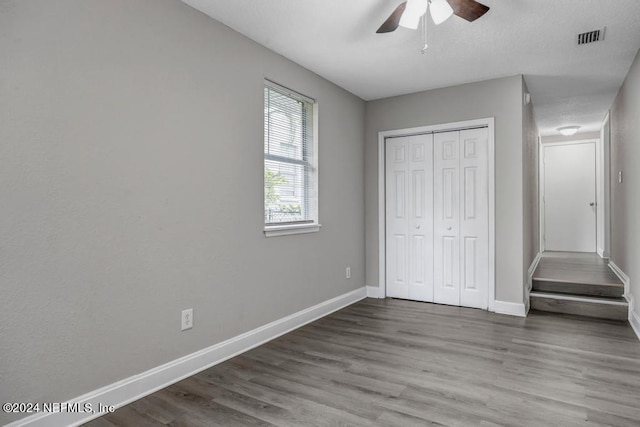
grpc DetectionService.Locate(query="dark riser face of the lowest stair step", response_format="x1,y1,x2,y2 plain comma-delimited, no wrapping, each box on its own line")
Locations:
530,295,629,320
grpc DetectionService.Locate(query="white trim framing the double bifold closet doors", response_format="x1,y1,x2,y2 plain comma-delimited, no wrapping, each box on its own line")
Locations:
378,117,496,311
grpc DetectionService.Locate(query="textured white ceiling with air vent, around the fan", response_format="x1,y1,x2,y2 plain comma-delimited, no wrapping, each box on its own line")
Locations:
183,0,640,135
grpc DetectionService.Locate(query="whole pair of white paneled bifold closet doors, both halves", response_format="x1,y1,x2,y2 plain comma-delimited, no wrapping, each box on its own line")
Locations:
386,128,489,309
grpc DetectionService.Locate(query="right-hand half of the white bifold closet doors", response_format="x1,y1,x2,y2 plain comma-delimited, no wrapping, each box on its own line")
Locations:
433,128,489,309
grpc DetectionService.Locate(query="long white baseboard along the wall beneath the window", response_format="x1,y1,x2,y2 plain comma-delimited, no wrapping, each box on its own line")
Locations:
5,286,367,427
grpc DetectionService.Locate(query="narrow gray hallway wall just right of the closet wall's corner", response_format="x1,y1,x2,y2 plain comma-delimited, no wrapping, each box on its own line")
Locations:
522,80,540,274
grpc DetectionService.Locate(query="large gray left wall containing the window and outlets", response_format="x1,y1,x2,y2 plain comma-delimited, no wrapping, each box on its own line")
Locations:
0,0,365,424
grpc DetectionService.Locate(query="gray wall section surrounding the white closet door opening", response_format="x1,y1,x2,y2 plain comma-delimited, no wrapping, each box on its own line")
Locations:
365,76,528,303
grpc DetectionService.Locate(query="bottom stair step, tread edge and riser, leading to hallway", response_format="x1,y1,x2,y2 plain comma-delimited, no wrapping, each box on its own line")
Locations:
529,291,629,320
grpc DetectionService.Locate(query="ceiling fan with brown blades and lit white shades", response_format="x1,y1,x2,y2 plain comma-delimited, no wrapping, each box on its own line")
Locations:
376,0,489,33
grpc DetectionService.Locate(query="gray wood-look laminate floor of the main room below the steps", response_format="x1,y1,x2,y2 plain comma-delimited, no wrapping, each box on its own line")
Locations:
89,299,640,427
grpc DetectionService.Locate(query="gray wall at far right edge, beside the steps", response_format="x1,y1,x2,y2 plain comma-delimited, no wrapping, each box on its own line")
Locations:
610,48,640,316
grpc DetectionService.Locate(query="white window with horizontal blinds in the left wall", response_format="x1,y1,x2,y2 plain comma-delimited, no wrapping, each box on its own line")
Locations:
264,81,319,236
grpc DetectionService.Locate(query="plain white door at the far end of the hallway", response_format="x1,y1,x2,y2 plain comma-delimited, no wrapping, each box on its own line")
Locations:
542,141,596,252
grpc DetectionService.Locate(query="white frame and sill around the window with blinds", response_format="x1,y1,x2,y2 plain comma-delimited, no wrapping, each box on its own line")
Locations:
262,79,321,237
